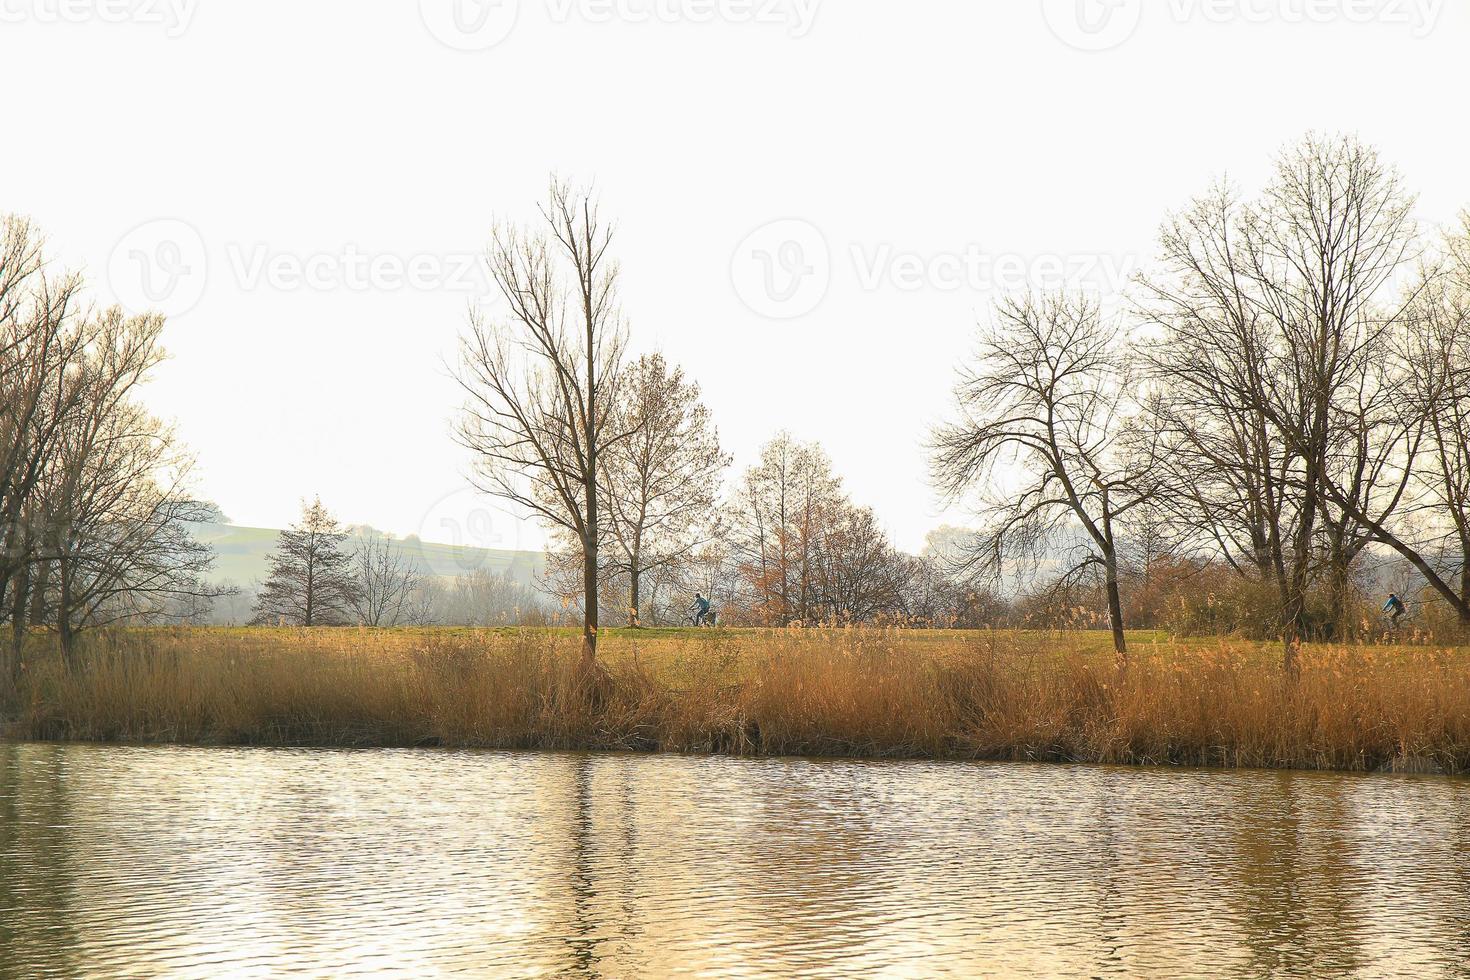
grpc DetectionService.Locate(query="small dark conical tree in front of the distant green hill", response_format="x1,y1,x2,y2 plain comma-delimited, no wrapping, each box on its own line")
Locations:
253,498,357,626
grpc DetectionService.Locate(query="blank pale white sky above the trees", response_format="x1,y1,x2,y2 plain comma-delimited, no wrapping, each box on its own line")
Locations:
0,0,1470,550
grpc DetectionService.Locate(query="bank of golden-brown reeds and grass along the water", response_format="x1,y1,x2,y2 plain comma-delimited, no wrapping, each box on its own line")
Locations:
9,629,1470,773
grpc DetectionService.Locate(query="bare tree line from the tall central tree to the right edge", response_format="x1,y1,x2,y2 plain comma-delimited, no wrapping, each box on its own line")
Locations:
457,135,1470,667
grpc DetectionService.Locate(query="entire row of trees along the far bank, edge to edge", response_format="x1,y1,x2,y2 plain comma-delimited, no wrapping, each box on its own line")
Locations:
0,137,1470,679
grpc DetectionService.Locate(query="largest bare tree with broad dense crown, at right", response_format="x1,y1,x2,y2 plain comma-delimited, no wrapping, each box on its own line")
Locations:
1145,137,1433,655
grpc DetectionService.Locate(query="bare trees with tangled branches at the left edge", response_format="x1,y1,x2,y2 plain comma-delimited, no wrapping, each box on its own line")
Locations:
0,219,219,683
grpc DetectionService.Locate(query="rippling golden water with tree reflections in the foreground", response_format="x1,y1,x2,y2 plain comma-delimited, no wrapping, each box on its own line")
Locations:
0,745,1470,977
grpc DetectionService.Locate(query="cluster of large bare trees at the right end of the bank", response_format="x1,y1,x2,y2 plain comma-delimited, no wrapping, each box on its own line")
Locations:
933,135,1470,669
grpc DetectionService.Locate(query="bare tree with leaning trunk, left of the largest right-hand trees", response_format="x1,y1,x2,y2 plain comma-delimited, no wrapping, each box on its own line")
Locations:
932,294,1155,663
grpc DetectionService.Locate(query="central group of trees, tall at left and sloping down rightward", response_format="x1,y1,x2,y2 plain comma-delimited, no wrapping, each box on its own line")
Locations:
456,181,999,663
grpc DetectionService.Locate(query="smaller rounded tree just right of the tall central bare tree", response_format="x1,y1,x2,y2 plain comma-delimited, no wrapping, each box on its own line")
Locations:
603,354,729,626
